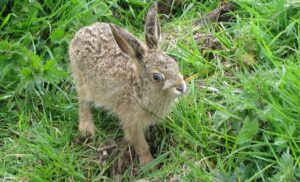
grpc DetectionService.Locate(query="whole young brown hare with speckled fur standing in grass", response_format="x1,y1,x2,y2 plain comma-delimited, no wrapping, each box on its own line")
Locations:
69,4,186,165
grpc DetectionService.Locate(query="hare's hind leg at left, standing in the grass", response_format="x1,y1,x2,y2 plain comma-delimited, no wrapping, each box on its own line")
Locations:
77,84,96,136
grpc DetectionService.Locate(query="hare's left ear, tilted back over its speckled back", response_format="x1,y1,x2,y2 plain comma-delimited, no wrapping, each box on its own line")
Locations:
109,24,146,60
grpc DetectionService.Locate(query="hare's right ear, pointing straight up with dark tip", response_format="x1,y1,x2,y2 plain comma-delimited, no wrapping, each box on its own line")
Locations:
145,3,160,49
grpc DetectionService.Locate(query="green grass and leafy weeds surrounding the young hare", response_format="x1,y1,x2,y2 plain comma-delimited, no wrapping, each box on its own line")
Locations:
0,0,300,181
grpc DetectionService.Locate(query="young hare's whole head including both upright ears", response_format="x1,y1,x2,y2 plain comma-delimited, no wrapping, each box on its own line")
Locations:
110,4,186,97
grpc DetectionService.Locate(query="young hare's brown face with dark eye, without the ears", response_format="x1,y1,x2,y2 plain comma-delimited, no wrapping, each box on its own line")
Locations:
145,50,186,97
